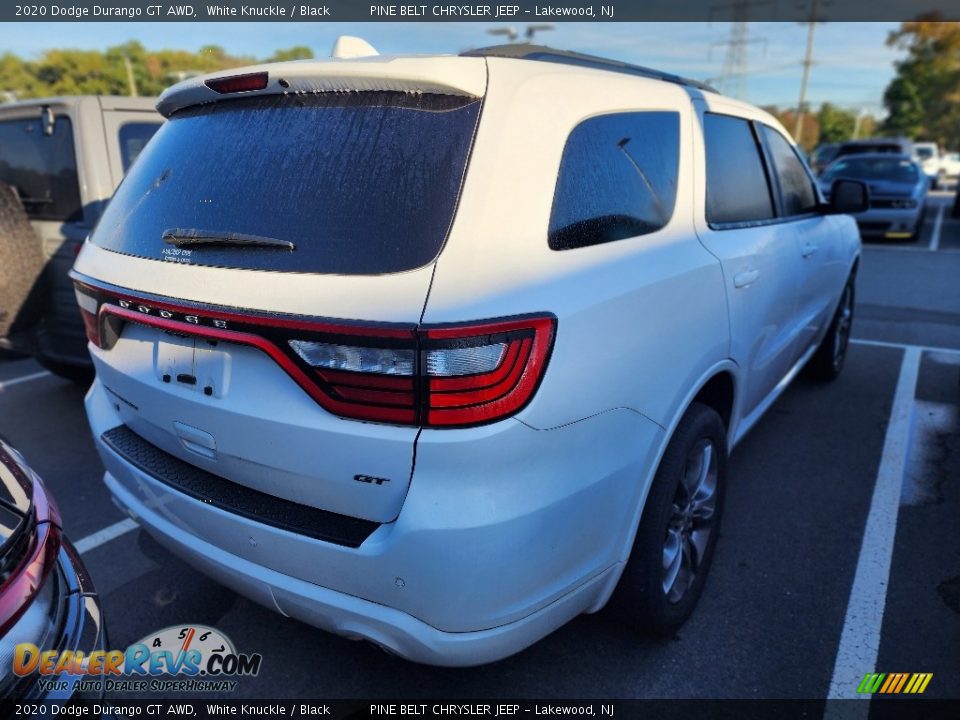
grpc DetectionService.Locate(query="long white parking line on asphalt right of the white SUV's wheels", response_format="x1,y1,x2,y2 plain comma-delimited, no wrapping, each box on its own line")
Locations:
824,348,922,717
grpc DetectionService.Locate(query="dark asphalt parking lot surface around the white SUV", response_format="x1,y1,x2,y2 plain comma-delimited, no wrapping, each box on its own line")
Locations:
0,192,960,699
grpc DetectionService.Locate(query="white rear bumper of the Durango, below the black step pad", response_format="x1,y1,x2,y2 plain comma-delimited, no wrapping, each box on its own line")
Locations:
87,381,662,665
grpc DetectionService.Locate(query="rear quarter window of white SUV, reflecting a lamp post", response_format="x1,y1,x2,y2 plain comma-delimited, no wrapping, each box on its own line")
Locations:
548,112,680,250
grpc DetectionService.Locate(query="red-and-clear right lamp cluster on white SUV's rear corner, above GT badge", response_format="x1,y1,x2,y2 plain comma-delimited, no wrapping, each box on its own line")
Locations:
288,316,556,427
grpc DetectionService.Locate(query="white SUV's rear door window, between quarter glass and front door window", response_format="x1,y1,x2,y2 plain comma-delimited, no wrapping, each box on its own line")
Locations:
703,113,774,224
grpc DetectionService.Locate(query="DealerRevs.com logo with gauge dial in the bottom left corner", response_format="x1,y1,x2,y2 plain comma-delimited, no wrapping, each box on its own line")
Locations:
13,625,263,692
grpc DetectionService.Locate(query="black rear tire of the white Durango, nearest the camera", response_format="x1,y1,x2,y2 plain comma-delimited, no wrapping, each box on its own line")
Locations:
611,403,727,637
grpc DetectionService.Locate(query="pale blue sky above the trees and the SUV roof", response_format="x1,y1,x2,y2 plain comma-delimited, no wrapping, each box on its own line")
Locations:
0,22,903,114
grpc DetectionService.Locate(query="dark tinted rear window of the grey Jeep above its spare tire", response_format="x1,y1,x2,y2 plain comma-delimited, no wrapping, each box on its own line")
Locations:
0,115,83,222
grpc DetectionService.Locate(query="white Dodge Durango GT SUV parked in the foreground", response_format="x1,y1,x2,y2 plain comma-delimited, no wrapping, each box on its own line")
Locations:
73,45,866,665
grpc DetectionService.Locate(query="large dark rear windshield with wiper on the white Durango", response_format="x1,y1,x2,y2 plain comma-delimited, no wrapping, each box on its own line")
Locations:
93,92,480,275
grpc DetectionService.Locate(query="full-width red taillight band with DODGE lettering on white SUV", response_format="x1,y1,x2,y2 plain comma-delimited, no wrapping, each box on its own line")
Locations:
77,283,556,427
